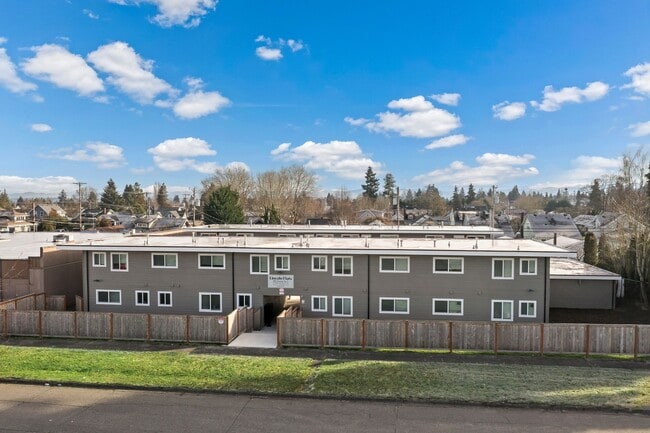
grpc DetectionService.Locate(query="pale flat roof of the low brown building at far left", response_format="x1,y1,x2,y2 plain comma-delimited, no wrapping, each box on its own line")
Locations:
0,232,124,260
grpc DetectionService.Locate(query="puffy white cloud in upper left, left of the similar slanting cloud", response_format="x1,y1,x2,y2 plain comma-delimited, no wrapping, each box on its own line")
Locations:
21,44,104,96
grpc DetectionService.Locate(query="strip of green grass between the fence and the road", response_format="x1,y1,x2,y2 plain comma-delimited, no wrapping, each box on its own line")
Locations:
0,346,650,410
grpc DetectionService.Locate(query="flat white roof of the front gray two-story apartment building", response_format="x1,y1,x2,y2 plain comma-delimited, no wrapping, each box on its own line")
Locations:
58,235,575,257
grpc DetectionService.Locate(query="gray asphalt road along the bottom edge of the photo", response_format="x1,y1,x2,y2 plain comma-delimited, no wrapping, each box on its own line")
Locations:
0,384,650,433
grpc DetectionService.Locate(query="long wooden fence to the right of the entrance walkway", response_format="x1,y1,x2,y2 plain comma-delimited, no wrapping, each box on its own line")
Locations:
277,316,650,358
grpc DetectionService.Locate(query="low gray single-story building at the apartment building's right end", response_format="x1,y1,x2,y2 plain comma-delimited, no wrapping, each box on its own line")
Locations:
551,258,624,309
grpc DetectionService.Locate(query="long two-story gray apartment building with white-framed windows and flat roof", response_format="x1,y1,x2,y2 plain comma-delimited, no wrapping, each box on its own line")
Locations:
59,236,575,322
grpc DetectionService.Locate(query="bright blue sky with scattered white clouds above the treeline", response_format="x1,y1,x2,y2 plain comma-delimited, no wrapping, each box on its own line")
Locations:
0,0,650,195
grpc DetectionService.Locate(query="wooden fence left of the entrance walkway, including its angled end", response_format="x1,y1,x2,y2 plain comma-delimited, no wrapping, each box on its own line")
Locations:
0,308,261,344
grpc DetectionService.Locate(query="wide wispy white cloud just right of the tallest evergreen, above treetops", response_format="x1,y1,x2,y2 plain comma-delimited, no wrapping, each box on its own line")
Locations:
413,153,539,187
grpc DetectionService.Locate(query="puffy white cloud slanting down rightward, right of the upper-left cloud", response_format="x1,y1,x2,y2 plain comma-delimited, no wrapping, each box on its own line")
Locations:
88,42,177,104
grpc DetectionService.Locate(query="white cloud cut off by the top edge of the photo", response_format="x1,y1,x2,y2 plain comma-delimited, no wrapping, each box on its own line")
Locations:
110,0,217,28
